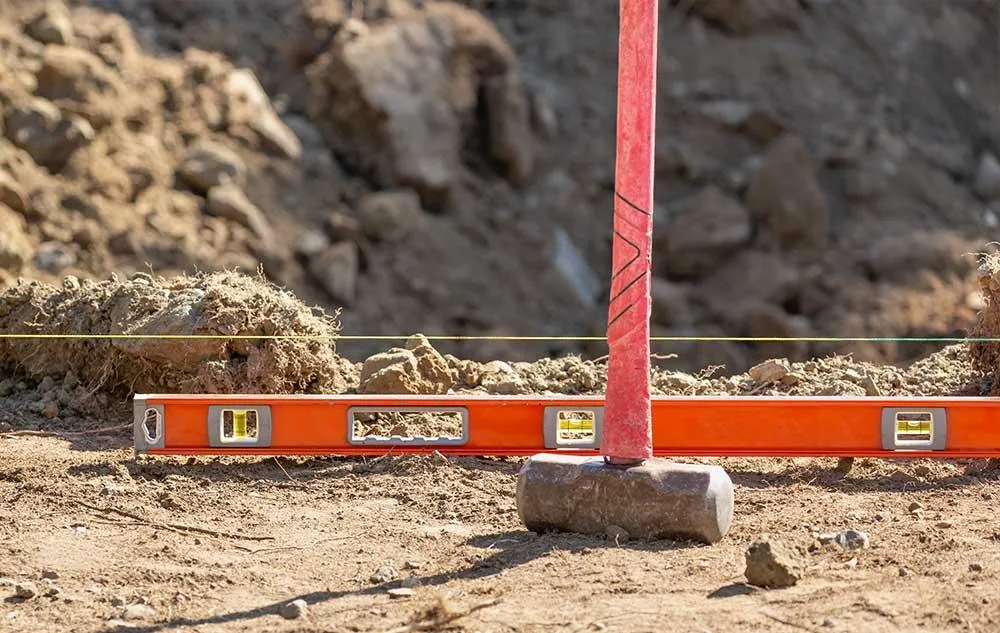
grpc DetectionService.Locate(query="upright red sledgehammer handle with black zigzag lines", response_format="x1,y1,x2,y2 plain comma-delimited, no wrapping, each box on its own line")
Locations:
601,0,659,463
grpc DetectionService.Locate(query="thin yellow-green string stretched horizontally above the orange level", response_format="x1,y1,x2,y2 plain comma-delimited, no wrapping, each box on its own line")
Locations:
0,333,1000,343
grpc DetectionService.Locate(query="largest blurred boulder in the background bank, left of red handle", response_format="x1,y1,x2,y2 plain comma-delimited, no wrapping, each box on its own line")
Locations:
308,3,532,207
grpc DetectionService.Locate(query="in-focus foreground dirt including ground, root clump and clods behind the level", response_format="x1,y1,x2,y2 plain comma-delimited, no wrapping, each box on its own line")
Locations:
0,272,1000,632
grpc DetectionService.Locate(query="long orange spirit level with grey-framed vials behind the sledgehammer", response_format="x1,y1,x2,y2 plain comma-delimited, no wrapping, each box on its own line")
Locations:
134,394,1000,458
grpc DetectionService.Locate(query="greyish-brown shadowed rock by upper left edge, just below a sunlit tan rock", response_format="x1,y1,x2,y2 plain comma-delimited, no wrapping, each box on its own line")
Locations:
7,98,95,173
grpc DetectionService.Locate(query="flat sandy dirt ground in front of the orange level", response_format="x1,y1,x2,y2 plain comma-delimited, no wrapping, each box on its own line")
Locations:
0,436,1000,633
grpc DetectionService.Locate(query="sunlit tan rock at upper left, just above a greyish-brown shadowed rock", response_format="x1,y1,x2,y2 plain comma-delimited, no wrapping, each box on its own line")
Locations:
35,45,130,128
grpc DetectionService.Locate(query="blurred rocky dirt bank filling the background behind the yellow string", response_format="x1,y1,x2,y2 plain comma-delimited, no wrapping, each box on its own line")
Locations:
0,0,1000,370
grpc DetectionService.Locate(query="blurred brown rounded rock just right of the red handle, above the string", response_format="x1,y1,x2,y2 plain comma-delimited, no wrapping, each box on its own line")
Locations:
654,185,752,277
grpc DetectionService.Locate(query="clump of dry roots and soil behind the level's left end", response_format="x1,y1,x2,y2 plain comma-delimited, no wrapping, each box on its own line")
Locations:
0,272,350,393
